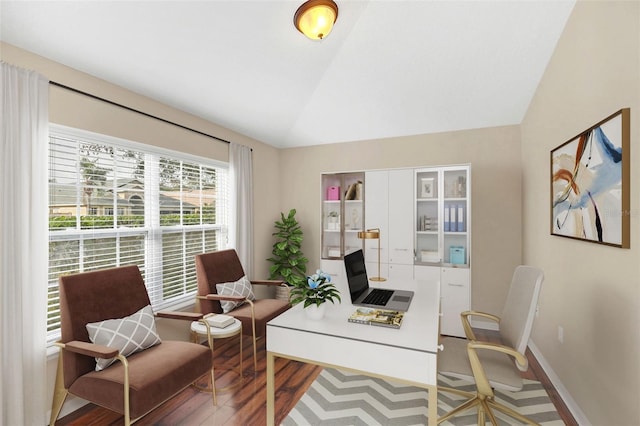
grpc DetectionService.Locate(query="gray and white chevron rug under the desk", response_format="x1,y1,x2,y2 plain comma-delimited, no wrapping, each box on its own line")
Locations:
282,368,564,426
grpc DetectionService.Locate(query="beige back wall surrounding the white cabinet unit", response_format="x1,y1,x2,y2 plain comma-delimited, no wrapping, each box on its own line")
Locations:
280,126,522,314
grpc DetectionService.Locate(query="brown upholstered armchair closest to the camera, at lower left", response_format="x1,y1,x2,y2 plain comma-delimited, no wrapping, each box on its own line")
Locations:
50,266,212,425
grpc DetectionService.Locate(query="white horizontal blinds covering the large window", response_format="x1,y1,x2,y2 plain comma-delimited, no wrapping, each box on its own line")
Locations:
47,126,228,342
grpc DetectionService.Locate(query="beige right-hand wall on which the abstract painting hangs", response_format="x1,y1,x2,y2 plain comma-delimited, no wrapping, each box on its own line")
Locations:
521,1,640,425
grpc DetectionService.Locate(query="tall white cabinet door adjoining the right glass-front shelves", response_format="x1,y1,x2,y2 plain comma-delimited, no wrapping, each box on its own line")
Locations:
388,169,414,265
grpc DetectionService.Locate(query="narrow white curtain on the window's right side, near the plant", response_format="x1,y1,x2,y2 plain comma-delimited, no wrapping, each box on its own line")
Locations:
229,142,253,279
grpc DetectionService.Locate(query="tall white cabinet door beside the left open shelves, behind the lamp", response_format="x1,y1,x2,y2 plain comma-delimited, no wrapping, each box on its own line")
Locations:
364,170,389,264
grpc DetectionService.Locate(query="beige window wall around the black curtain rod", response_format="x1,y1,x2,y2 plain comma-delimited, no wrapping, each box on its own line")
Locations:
0,42,280,277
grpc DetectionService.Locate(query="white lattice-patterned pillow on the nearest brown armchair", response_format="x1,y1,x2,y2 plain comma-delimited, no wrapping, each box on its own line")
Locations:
87,305,160,371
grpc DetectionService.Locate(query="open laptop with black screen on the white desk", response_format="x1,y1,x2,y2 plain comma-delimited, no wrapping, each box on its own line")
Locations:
344,249,414,312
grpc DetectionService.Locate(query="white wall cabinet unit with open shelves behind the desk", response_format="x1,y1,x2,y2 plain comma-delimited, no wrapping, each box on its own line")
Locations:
320,165,471,336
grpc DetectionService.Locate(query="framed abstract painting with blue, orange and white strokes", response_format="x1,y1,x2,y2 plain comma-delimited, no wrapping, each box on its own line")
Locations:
551,108,631,248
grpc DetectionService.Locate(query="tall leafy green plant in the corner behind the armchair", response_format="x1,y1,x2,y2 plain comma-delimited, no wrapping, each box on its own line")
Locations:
267,209,308,299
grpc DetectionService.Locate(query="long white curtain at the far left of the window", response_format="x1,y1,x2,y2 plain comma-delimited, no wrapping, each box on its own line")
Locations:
0,63,49,425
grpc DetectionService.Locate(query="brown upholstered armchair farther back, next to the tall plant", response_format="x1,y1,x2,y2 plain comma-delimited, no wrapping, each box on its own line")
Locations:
196,249,290,371
